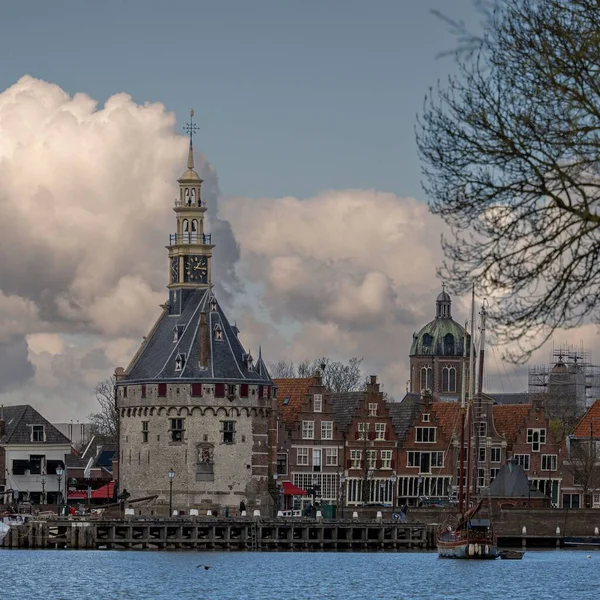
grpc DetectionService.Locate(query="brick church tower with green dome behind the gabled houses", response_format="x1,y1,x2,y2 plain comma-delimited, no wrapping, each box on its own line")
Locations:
410,289,471,400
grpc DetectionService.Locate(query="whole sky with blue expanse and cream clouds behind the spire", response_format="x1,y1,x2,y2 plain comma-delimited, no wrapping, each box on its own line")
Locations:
0,0,597,420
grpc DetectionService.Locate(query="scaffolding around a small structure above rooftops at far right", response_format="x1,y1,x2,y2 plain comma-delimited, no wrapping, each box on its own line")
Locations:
528,345,600,409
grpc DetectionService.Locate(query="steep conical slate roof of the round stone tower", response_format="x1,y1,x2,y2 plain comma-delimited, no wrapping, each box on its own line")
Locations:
120,288,272,384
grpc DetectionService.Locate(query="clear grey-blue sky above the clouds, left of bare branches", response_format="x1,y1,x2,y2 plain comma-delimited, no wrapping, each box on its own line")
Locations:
0,0,476,200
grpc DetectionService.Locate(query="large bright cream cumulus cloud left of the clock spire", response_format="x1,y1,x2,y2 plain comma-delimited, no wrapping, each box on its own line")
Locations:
0,76,240,418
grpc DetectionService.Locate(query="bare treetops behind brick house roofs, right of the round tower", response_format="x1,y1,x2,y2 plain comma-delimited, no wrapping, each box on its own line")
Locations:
269,356,365,392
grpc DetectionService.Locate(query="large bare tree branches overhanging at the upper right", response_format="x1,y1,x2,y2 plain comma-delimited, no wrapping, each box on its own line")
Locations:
417,0,600,361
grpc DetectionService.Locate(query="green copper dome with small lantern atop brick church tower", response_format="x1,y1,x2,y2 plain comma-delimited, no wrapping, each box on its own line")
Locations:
410,290,471,356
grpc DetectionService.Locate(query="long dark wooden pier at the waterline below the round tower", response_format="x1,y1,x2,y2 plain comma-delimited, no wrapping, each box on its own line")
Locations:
0,517,435,552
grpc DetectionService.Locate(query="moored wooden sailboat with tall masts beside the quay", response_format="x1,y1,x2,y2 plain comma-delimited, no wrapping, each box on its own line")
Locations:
437,286,499,560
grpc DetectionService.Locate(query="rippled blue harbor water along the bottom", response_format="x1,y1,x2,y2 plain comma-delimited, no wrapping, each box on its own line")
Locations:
0,550,600,600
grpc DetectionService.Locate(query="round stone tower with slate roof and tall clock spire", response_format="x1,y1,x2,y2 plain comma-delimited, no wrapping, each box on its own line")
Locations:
115,111,275,514
